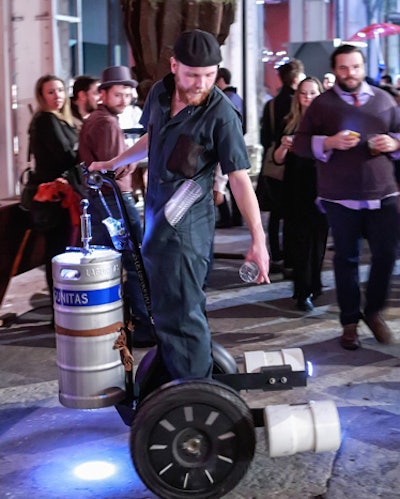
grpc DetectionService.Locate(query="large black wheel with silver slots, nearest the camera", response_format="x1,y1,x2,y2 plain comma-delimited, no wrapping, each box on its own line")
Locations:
130,380,255,499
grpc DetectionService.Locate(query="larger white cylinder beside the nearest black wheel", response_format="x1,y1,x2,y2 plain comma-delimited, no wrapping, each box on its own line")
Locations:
264,400,340,457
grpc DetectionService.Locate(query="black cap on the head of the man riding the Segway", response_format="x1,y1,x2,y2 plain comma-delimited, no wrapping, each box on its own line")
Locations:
174,29,222,68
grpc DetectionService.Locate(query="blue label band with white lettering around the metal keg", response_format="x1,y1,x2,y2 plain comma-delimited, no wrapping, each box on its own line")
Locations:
54,284,122,307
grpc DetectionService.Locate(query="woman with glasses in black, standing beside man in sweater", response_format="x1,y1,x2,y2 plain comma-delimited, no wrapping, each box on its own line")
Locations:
274,76,328,312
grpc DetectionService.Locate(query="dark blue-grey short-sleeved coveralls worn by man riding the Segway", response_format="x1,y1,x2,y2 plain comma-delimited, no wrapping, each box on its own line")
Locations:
141,74,250,379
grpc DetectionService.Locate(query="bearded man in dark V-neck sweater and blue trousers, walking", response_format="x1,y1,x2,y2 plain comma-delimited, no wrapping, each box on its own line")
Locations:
294,45,400,350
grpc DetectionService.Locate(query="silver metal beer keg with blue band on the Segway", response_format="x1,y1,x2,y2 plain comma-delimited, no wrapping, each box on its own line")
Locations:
52,248,125,409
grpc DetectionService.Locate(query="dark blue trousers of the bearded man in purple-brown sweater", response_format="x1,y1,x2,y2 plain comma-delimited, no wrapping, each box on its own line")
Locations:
322,196,400,325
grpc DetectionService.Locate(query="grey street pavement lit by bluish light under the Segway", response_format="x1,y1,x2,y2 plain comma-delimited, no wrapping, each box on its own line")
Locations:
0,227,400,499
